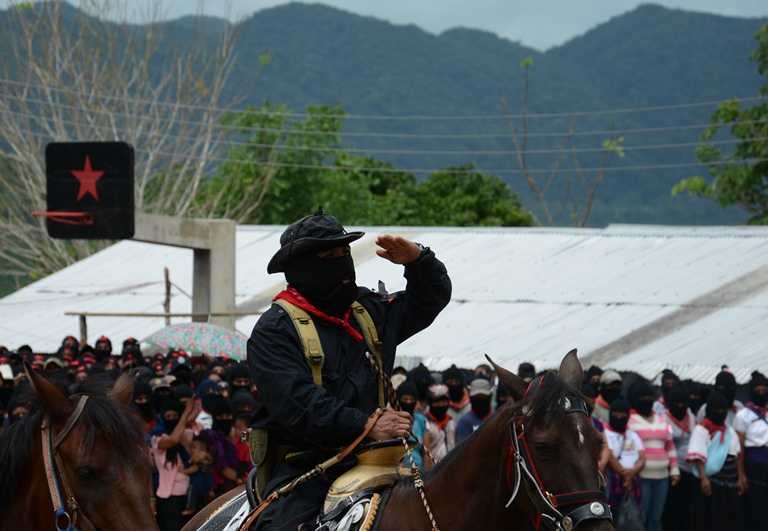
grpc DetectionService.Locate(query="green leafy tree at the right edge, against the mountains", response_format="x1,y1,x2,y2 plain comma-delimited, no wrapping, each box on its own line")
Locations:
672,25,768,225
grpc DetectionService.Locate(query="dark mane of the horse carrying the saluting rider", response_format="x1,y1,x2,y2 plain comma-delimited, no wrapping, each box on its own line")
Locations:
425,371,582,478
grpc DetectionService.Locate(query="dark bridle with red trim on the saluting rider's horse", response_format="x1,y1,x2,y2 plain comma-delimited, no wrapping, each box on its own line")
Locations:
505,378,613,531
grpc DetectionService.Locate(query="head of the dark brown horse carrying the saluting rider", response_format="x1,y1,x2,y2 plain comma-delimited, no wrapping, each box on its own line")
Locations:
489,350,613,531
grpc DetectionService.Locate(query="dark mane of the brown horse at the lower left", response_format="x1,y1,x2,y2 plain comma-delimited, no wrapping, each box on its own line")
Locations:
0,376,145,512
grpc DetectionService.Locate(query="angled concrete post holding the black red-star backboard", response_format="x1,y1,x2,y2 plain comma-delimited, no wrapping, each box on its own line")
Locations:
133,212,236,330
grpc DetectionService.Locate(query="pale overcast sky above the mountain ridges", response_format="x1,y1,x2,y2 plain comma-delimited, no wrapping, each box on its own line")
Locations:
158,0,768,50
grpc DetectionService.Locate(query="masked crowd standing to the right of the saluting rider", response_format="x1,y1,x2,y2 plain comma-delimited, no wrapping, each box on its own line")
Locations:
392,363,768,531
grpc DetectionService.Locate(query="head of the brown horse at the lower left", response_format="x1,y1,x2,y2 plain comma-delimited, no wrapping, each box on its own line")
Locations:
27,368,157,531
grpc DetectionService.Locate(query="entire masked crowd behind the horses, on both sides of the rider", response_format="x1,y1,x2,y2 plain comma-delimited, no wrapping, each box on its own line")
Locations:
0,336,768,531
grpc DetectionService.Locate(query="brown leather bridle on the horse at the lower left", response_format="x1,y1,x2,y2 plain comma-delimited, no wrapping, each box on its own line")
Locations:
40,395,93,531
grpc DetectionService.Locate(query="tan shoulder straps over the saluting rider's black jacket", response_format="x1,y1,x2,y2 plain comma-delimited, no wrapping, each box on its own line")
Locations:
274,299,387,408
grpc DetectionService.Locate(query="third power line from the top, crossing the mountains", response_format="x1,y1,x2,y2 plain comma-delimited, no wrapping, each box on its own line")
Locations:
0,111,768,156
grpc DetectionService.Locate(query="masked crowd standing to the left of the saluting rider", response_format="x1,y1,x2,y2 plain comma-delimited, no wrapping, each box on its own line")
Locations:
0,336,257,531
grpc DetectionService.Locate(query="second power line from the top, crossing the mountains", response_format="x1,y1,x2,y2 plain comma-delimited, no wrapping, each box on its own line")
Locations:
0,94,768,139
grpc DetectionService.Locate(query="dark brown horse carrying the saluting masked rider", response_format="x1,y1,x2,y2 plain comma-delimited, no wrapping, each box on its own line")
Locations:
184,350,613,531
